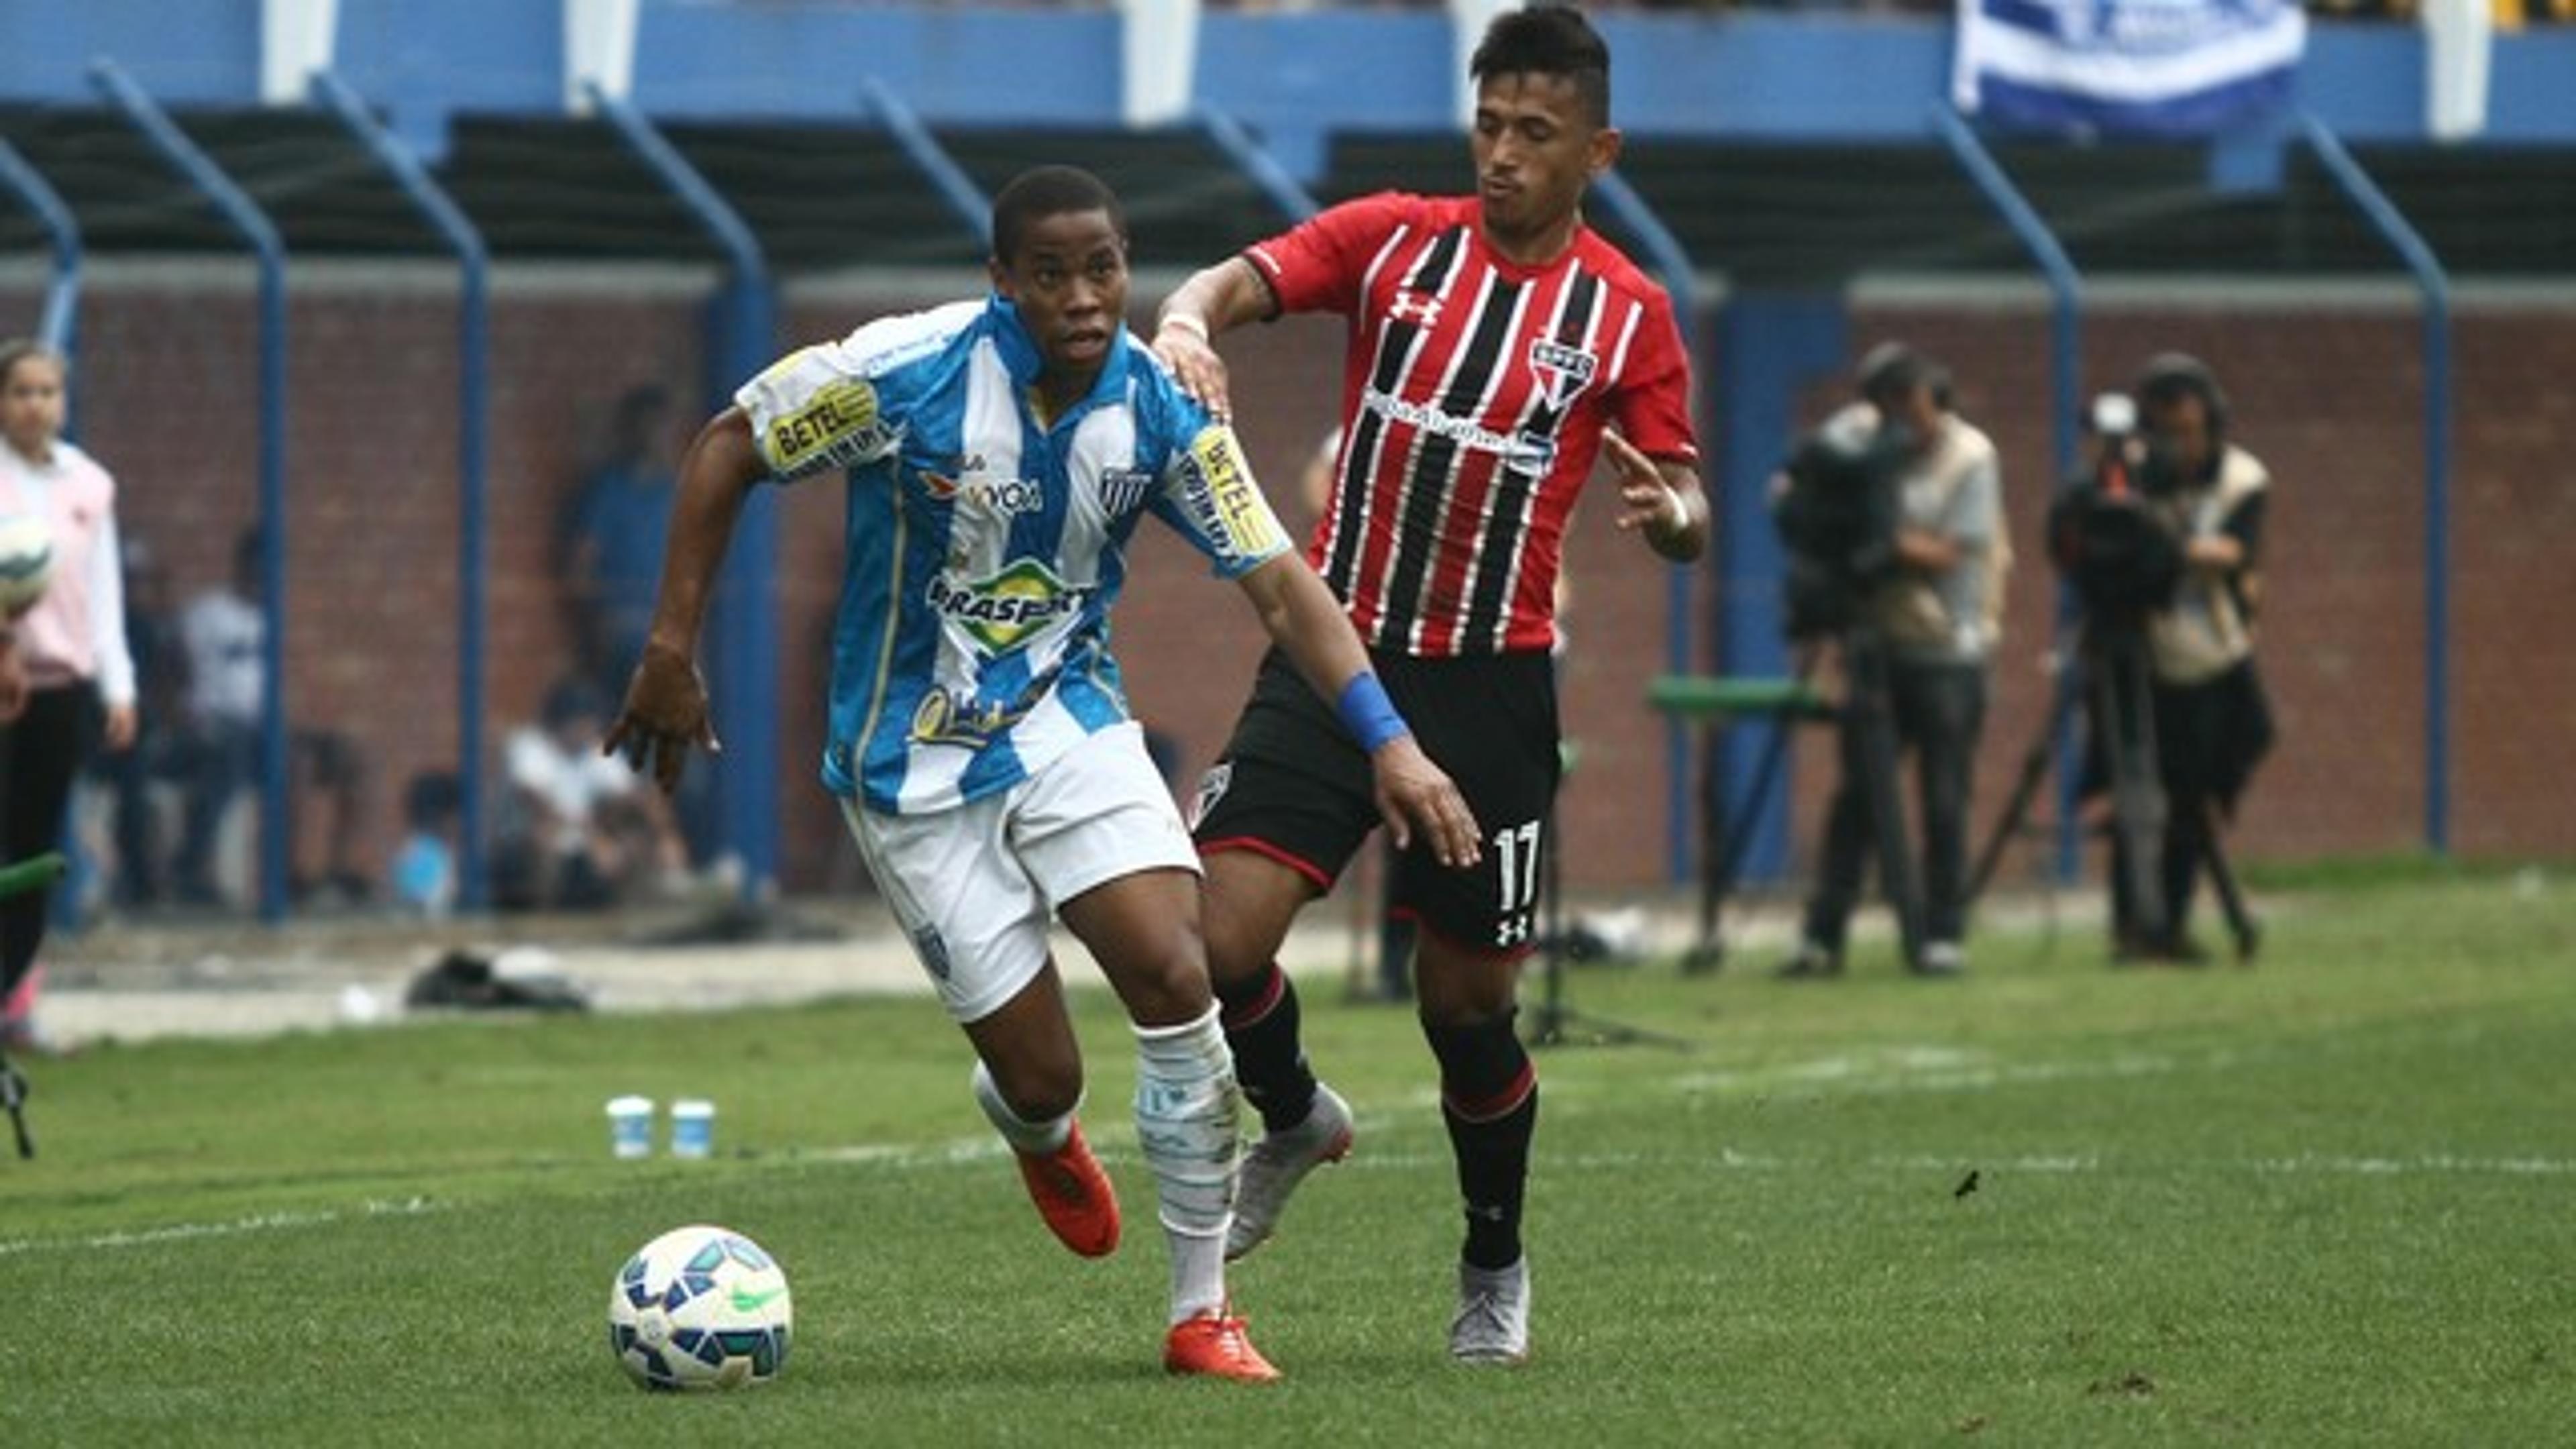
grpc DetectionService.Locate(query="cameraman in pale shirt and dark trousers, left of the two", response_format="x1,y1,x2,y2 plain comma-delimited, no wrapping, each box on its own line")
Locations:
1780,343,2009,977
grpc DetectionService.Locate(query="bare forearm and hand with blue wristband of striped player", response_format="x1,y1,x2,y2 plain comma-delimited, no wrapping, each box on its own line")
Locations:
1239,551,1481,866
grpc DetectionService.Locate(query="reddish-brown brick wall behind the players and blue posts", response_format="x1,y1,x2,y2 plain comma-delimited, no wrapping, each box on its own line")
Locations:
25,263,2576,887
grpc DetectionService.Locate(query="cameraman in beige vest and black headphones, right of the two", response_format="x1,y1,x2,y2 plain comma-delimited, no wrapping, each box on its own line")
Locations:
2112,354,2272,964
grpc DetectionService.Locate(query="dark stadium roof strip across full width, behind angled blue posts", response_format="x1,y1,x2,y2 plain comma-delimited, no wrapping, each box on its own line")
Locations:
0,106,2576,286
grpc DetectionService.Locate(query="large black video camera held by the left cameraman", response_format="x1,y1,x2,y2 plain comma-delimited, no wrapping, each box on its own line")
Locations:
1772,425,1907,639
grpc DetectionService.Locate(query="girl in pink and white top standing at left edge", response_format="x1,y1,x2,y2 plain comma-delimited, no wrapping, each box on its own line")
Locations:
0,340,137,1046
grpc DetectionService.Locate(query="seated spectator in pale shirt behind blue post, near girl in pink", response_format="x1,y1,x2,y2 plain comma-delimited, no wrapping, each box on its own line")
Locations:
172,526,374,905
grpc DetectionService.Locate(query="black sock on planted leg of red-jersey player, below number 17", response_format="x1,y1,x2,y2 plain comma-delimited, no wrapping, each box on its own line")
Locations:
1422,1011,1538,1269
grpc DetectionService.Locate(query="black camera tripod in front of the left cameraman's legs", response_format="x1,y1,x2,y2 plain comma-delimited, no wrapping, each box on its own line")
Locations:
1682,624,1924,975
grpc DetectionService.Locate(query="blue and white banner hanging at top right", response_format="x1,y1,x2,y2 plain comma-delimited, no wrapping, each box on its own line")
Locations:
1950,0,2308,137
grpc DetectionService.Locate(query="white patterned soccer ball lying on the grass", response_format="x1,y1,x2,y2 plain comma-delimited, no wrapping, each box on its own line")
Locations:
608,1225,796,1390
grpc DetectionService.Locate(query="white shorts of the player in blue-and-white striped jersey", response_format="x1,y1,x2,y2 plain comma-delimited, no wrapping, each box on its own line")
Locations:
840,722,1198,1024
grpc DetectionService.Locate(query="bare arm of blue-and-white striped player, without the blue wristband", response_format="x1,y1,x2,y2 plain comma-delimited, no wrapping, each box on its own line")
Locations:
600,407,770,794
